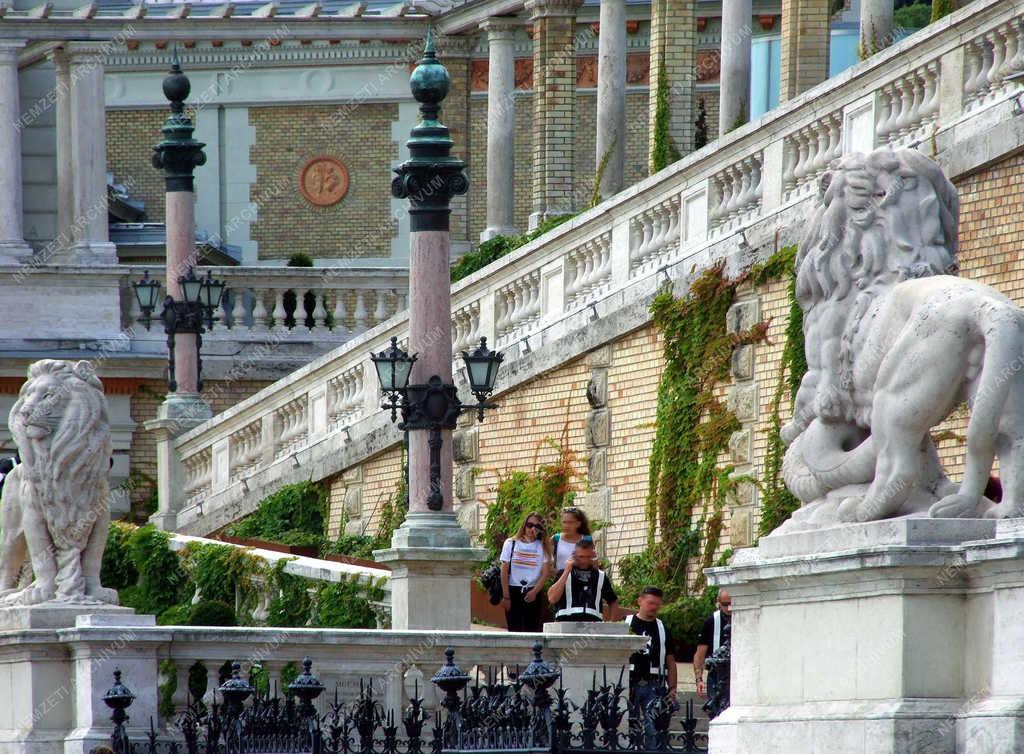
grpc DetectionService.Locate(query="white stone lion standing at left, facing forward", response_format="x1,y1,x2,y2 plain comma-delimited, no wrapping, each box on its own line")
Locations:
0,359,118,604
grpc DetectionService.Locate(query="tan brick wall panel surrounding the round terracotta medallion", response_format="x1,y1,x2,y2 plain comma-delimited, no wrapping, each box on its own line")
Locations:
249,102,398,259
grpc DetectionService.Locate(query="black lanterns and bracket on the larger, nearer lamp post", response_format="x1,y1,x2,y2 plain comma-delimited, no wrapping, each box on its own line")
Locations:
370,338,505,510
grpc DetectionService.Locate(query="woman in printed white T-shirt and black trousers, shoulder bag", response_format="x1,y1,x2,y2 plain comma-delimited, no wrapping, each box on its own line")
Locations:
501,513,551,631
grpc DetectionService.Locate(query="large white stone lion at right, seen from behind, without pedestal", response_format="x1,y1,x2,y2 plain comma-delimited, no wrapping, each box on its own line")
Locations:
779,150,1024,531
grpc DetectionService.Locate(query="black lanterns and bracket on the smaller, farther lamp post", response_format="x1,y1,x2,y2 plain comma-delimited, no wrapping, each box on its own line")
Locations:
132,267,224,392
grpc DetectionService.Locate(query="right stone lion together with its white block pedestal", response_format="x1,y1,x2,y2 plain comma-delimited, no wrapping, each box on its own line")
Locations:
707,150,1024,754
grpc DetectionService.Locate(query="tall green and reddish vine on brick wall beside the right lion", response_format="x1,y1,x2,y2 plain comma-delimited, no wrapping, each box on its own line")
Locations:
620,247,806,641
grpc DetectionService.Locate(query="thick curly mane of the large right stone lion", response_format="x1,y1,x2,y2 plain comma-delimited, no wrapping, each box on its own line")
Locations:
797,150,959,312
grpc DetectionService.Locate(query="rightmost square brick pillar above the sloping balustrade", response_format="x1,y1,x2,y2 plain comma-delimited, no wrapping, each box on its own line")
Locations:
779,0,829,101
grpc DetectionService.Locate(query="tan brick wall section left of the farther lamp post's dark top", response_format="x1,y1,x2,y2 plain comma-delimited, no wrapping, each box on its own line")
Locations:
106,110,171,222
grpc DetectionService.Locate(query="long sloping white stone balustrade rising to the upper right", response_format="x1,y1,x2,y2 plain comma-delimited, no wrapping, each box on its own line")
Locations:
160,0,1024,534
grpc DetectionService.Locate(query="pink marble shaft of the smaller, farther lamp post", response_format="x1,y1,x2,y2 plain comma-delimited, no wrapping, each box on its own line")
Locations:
164,192,199,393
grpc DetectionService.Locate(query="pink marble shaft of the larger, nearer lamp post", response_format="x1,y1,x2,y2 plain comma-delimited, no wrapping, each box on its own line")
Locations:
409,231,453,512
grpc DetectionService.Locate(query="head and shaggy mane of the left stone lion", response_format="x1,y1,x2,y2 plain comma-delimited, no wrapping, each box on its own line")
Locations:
8,360,112,550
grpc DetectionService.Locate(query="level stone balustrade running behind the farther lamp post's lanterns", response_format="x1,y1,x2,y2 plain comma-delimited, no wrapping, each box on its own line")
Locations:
121,265,409,340
